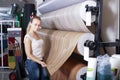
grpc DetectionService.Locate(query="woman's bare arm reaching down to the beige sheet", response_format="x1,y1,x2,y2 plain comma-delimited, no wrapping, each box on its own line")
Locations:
24,37,46,67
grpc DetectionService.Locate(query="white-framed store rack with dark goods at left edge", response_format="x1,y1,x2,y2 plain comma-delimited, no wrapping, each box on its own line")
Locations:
0,20,19,68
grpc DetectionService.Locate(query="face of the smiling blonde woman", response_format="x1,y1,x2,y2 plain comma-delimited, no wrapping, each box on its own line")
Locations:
31,19,42,32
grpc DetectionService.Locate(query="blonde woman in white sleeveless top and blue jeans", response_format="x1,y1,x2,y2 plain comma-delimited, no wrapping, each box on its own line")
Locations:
24,16,47,80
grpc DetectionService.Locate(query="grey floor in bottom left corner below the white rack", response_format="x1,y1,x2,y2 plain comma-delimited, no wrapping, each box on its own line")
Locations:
0,69,13,80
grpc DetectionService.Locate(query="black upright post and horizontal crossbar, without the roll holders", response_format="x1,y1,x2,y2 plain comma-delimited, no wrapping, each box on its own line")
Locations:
95,0,120,56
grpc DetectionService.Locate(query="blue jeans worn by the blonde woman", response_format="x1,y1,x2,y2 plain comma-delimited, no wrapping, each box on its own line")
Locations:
25,59,48,80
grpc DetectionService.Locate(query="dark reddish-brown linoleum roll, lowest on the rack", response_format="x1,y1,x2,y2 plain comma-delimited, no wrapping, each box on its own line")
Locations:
52,57,87,80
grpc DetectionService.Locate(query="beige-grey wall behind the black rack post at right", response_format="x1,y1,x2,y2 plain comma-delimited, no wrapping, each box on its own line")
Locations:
102,0,119,54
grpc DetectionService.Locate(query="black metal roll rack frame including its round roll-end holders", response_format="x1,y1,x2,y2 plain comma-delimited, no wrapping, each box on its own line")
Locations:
84,0,120,57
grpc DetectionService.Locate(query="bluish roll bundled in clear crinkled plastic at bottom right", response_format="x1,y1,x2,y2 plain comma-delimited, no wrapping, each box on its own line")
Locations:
97,54,112,80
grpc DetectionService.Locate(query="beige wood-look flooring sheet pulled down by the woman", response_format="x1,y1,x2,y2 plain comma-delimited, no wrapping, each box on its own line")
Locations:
39,29,92,75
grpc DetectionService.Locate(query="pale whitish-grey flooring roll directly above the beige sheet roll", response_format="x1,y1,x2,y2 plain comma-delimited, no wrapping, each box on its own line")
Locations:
40,0,96,32
